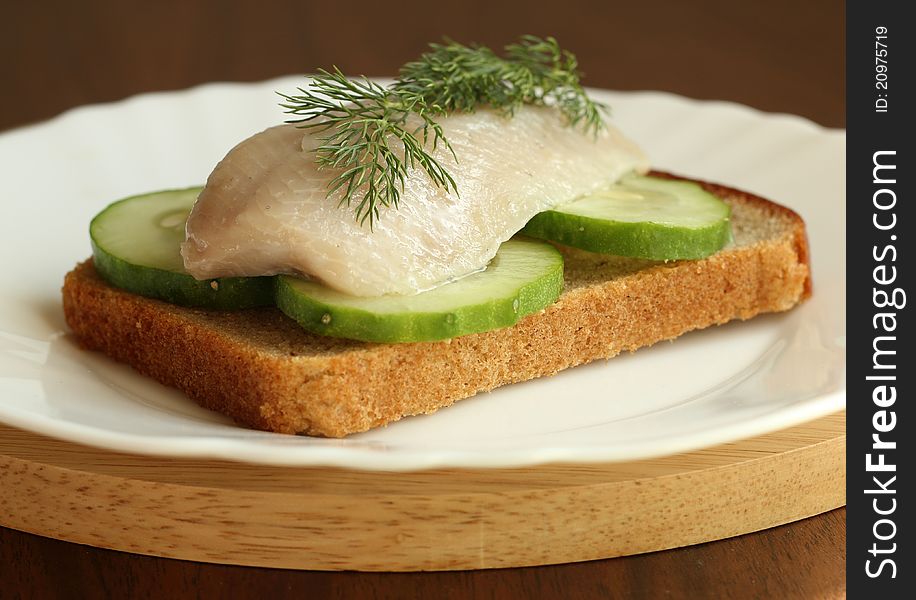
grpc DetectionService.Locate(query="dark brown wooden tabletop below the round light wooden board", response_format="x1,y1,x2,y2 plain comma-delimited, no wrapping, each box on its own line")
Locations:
0,509,846,600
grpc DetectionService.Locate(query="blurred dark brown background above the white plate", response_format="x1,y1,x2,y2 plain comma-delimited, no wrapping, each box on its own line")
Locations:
0,0,845,129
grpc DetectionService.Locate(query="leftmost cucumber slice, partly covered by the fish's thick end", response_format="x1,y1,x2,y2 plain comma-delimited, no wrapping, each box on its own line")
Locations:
89,187,274,310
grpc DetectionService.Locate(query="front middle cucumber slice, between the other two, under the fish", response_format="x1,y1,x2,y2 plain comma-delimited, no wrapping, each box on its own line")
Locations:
277,240,563,342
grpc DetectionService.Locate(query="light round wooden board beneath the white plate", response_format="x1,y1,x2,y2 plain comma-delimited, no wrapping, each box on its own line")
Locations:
0,412,846,571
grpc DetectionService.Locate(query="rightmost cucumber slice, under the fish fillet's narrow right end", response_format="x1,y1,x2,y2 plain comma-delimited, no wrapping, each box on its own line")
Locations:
522,176,731,260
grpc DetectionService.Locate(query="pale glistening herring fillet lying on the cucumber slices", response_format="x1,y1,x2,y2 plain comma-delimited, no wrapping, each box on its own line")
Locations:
181,107,648,296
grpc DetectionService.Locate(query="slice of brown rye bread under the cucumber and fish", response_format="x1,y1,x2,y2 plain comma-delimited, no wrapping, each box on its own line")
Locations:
63,173,811,437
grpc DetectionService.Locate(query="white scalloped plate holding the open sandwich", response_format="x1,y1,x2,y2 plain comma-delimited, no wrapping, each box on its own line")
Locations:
0,78,846,470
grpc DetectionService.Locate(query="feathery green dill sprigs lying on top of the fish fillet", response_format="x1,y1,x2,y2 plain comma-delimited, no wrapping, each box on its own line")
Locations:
280,35,606,227
